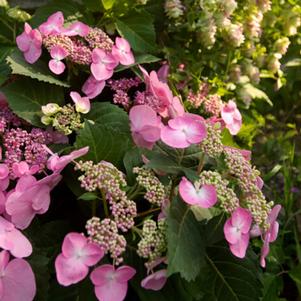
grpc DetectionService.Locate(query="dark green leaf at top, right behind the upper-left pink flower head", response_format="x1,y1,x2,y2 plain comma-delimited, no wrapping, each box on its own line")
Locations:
116,12,157,53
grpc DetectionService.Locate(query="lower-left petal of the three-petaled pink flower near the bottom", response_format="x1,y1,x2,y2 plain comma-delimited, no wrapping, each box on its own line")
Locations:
55,254,89,286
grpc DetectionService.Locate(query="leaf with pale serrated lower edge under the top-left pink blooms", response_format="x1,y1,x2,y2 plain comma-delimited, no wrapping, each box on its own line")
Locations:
7,50,69,87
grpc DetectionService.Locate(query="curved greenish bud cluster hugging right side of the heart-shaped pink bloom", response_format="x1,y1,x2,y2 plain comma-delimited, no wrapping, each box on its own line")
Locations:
198,170,239,213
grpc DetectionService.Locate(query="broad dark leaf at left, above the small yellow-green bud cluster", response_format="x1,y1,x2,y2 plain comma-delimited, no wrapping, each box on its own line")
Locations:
2,78,64,126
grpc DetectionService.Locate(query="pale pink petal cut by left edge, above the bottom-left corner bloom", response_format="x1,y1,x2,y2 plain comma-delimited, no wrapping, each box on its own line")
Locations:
0,216,32,256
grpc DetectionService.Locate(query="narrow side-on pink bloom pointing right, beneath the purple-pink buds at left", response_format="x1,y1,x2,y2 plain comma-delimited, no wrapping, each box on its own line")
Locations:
44,146,89,173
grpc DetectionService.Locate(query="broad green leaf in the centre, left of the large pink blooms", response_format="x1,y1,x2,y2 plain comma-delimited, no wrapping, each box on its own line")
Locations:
75,122,132,167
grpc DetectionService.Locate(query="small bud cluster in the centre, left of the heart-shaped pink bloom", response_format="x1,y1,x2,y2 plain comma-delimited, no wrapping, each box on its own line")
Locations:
133,167,168,207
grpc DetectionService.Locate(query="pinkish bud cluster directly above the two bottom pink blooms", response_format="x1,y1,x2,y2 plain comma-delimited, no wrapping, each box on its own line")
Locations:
86,217,126,265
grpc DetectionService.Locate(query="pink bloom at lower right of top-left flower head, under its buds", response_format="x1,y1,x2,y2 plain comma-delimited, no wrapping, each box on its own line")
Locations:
90,48,118,81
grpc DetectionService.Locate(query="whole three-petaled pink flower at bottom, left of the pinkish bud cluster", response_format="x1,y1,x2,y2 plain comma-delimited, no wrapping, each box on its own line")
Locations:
55,232,104,286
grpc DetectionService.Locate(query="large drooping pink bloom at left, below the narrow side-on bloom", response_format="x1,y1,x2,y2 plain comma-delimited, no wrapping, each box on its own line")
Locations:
5,174,61,229
